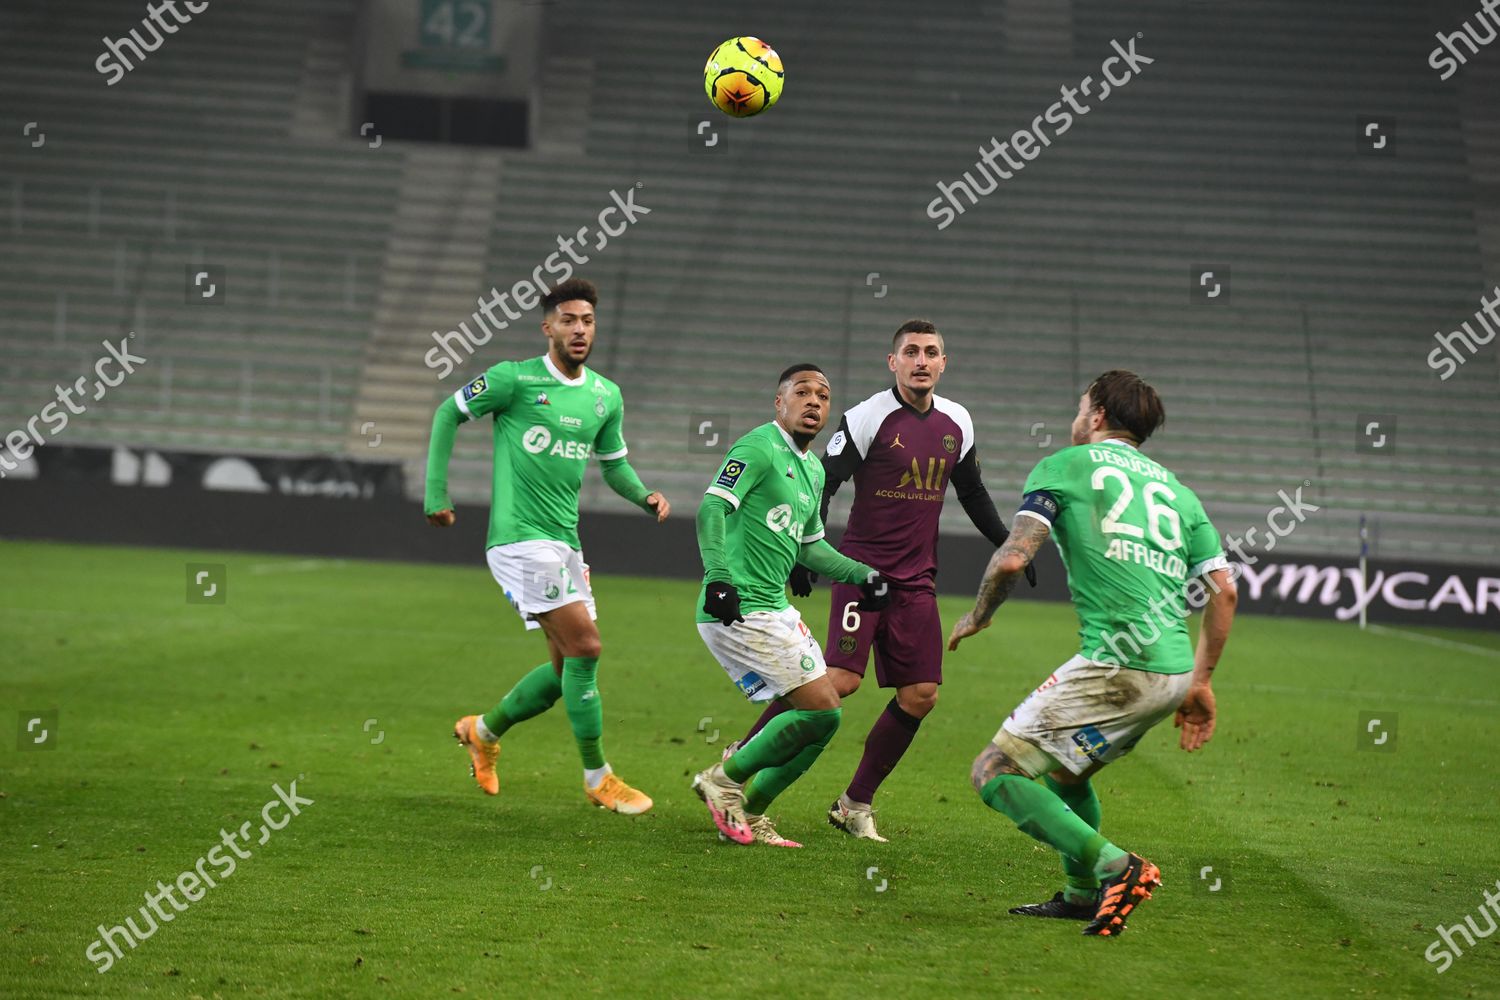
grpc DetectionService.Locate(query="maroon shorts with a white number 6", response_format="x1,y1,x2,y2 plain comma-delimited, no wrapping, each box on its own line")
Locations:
824,583,944,688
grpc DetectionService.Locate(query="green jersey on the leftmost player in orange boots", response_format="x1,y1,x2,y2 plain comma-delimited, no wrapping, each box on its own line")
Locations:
453,354,626,549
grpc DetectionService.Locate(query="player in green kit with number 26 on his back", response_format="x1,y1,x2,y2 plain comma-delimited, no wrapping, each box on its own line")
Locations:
948,370,1236,937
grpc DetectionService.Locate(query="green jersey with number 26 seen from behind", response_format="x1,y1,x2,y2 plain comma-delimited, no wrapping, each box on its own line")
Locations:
1019,441,1229,673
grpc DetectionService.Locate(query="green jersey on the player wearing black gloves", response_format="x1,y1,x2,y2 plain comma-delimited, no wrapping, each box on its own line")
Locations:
698,421,824,622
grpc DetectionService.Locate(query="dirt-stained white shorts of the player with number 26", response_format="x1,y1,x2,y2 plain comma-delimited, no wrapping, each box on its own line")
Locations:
995,657,1193,774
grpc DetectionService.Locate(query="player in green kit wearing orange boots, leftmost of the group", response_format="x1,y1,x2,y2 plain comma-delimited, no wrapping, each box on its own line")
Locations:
425,279,671,814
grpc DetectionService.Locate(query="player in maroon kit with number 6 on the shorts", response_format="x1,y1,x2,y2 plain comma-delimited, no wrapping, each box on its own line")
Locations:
726,319,1037,843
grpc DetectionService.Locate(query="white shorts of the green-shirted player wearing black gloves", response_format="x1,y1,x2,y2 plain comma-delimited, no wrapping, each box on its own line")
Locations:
698,607,828,702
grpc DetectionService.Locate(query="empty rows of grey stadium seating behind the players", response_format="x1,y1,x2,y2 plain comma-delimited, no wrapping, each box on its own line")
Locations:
0,0,1500,561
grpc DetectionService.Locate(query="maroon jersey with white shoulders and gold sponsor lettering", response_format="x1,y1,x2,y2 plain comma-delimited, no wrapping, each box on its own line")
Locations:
824,387,978,589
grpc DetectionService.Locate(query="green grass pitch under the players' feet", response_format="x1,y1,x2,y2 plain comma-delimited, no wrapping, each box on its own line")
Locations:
0,543,1500,997
